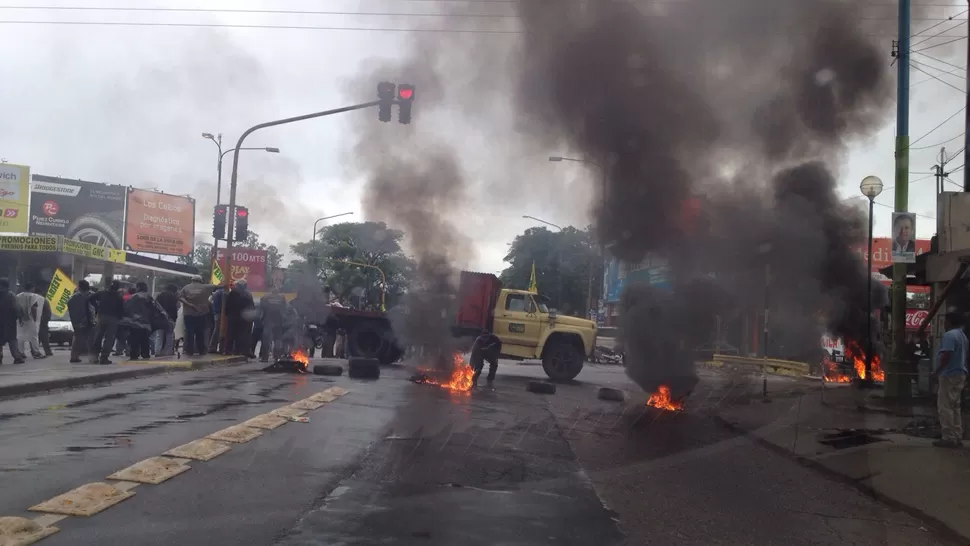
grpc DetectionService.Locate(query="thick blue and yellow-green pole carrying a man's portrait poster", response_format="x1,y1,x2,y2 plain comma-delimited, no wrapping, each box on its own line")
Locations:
885,0,910,398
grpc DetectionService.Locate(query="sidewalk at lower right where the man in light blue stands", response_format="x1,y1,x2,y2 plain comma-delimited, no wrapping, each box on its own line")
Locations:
713,382,970,540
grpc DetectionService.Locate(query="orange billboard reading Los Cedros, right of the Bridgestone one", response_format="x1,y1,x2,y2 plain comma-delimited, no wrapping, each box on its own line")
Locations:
125,188,195,256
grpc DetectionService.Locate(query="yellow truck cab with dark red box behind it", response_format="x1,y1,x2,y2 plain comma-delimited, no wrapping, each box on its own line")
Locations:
454,271,596,381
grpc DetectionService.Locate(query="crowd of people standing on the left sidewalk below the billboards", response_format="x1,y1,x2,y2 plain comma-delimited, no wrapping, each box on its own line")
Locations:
0,276,346,364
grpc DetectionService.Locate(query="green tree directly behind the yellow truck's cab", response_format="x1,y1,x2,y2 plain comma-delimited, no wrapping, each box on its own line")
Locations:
500,226,603,316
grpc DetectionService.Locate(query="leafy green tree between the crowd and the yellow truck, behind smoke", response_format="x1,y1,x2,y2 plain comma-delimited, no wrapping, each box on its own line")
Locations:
290,222,414,307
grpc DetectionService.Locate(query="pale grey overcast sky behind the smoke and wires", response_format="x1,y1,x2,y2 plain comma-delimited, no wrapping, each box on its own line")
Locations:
0,0,967,272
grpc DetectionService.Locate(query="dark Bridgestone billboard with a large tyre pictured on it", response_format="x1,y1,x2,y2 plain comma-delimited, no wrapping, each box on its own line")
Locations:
30,174,125,249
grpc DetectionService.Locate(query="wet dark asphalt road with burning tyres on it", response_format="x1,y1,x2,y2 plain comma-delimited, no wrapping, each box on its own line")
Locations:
0,362,947,546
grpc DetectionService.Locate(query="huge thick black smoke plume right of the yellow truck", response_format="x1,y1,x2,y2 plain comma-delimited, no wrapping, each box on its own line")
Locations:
518,0,892,395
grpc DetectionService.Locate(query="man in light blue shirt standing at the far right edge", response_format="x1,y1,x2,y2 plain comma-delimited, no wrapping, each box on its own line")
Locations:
933,312,970,447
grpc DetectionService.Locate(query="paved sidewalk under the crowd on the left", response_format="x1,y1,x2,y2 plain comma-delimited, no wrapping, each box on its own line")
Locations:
0,350,246,398
